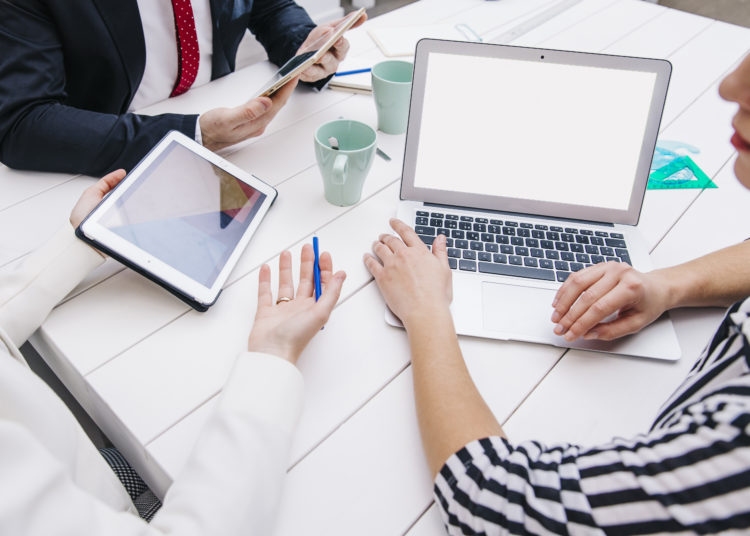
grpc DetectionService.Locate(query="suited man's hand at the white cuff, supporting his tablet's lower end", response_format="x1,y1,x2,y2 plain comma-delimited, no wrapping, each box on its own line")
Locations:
199,78,299,151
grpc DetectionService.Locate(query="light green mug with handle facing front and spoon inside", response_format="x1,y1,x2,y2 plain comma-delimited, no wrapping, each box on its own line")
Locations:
315,119,377,207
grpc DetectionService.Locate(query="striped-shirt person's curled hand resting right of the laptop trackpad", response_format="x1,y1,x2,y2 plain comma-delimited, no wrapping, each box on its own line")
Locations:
552,262,669,341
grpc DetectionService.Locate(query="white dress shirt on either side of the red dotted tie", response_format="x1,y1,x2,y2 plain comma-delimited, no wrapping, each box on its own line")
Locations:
130,0,213,111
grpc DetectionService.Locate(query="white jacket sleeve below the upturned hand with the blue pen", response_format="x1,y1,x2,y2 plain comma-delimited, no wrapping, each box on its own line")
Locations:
151,352,303,536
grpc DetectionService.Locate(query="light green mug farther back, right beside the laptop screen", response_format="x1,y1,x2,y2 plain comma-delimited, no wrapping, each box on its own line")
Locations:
372,60,414,134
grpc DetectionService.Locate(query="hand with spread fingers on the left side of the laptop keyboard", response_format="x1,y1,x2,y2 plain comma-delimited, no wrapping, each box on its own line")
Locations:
364,218,453,329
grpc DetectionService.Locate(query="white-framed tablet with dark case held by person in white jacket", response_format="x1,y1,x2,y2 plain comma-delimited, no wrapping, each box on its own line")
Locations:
76,131,277,311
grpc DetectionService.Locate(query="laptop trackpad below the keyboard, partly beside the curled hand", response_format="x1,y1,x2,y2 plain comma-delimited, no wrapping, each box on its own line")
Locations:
482,281,557,341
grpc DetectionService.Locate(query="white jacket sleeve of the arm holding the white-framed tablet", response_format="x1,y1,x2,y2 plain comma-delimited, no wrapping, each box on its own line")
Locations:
0,223,104,346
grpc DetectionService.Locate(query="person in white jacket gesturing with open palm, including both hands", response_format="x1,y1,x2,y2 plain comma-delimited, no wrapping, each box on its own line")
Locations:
0,170,346,536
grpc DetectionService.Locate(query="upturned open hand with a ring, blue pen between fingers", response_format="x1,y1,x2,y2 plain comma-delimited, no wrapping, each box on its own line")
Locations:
247,244,346,363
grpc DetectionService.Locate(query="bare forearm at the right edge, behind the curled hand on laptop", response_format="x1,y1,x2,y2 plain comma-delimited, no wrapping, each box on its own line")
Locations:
652,241,750,309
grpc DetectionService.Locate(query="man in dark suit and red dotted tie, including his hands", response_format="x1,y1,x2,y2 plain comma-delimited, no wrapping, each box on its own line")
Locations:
0,0,364,176
